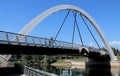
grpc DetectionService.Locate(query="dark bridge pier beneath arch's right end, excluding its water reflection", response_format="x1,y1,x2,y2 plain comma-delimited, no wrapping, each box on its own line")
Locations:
86,52,111,69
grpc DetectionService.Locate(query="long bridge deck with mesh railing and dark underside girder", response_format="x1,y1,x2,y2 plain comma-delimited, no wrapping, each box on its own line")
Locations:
0,31,82,55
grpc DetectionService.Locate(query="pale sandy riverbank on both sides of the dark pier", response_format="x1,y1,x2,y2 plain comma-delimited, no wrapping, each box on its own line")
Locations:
51,60,120,69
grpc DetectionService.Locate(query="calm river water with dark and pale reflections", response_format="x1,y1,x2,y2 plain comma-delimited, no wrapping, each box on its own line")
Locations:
31,66,120,76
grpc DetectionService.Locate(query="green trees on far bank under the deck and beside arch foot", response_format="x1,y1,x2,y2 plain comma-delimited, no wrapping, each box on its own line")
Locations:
11,47,120,64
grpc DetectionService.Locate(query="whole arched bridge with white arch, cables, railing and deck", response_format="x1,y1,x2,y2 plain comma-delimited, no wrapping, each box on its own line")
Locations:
0,5,116,75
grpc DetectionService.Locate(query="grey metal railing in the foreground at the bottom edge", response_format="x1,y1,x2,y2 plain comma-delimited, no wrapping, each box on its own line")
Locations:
24,66,57,76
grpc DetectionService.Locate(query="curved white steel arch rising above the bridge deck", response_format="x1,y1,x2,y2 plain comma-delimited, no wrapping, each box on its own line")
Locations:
0,5,117,61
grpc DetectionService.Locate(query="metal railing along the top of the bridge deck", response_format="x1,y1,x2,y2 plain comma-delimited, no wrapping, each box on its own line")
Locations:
0,31,82,49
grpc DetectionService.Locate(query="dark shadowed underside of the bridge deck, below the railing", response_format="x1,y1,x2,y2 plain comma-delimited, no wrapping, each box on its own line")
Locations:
0,44,80,55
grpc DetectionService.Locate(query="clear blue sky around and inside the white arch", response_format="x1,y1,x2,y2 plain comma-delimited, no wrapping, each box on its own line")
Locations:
0,0,120,49
